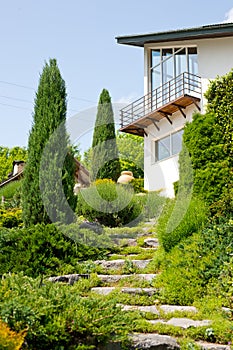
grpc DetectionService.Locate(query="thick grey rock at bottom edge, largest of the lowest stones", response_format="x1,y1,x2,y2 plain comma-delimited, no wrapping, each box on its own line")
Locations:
130,334,180,350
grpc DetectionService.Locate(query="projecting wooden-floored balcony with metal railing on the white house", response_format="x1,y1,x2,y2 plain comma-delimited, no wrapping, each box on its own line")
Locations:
120,72,201,136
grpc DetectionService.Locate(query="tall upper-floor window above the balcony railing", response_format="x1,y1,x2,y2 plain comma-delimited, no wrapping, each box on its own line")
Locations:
150,47,198,90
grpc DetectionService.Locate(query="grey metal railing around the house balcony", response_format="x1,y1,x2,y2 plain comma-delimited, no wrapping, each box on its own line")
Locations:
121,72,201,128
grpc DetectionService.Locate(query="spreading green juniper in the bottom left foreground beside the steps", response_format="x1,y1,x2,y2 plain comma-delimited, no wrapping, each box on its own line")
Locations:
0,275,133,350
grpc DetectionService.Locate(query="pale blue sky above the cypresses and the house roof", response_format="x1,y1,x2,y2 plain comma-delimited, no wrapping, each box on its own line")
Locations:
0,0,233,151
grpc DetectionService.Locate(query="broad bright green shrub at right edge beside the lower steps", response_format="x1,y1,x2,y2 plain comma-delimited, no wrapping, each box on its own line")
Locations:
154,220,233,306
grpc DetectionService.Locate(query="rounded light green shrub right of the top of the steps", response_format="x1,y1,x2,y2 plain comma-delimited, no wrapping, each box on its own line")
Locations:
156,198,208,252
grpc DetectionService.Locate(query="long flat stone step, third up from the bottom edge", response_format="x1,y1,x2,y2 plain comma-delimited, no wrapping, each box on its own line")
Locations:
119,304,198,315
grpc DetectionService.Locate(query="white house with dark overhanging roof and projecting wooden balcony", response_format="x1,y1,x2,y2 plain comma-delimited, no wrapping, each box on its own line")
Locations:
116,23,233,197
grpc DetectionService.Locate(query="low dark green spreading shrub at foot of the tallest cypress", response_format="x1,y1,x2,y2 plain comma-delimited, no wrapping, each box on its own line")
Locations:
0,224,104,277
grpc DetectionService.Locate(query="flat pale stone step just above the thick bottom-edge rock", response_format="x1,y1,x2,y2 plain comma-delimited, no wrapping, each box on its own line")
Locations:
148,317,211,329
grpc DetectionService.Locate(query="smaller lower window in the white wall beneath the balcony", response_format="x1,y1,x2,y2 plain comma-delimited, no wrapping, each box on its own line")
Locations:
155,130,183,162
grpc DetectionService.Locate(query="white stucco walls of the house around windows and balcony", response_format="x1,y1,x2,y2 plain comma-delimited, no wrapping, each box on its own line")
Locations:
144,37,233,197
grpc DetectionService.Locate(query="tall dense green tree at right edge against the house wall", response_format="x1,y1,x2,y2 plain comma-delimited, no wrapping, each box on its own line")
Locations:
180,71,233,204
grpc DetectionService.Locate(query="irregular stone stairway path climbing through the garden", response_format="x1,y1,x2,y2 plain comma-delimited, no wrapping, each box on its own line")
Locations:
49,221,230,350
